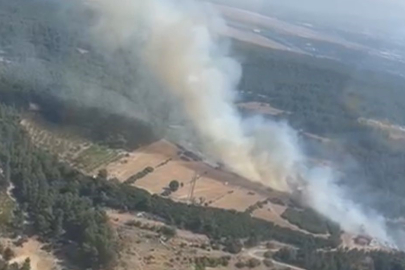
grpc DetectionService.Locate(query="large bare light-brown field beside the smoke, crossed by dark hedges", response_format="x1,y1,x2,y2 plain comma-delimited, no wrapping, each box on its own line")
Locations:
106,140,280,211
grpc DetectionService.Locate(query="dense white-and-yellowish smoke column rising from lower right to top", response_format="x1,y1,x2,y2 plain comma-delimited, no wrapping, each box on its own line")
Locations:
90,0,389,245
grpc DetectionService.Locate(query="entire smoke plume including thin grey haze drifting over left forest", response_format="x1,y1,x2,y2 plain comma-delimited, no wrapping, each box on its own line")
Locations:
0,0,400,250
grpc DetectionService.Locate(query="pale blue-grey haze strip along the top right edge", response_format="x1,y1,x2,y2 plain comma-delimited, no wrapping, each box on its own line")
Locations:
211,0,405,32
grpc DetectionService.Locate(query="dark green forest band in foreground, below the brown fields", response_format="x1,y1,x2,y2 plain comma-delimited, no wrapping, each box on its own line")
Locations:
0,103,405,270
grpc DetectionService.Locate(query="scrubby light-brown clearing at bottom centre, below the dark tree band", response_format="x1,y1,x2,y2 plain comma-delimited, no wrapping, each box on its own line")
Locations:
108,211,273,270
